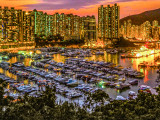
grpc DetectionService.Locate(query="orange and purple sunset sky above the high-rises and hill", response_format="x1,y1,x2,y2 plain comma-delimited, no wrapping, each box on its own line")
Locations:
0,0,160,20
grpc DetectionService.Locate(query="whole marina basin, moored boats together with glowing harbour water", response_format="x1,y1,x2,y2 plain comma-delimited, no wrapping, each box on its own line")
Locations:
0,48,159,102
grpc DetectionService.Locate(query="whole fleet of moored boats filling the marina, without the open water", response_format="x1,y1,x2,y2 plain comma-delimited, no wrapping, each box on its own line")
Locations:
0,48,158,103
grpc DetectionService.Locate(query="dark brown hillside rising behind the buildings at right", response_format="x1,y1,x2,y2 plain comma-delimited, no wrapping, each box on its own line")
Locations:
120,8,160,25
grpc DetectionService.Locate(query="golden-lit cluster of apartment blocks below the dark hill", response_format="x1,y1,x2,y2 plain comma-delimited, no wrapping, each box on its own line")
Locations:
120,20,160,40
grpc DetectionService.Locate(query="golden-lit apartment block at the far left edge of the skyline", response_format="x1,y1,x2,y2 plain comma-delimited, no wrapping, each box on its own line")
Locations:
0,7,22,42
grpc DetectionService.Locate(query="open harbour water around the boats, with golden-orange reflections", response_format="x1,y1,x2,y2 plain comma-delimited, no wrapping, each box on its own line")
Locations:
0,52,160,98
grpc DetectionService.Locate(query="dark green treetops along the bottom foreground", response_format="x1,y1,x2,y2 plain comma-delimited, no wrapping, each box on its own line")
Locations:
0,80,160,120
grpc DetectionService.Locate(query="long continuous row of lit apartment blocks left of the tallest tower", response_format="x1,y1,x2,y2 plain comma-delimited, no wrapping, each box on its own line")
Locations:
0,7,96,42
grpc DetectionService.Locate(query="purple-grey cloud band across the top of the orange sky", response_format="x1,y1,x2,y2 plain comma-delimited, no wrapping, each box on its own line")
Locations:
23,0,148,10
